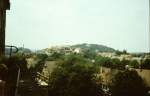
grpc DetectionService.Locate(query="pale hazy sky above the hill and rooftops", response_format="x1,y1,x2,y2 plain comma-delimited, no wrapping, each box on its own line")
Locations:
6,0,150,52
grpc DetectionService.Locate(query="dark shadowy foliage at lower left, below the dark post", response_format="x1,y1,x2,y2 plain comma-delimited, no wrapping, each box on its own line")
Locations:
0,56,27,96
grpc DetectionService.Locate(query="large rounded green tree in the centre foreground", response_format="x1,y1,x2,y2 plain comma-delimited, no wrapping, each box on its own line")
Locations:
49,55,102,96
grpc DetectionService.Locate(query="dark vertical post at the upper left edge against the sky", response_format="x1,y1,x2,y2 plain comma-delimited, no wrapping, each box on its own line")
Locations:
0,0,10,57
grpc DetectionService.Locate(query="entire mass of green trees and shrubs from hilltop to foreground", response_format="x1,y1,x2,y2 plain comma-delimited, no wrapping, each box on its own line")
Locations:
0,44,150,96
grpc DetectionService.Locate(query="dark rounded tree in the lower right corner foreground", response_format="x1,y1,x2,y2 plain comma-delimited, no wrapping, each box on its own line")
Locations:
111,70,148,96
